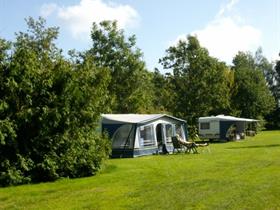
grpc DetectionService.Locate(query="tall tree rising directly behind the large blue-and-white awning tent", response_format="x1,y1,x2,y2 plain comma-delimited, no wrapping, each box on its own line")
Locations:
87,21,154,113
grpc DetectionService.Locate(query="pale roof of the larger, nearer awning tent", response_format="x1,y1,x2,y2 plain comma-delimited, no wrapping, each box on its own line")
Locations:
101,114,185,124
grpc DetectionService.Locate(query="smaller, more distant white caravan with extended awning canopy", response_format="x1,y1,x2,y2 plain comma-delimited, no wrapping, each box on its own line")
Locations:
198,115,258,140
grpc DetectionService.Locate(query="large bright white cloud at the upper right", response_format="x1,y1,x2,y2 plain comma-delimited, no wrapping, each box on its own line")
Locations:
173,0,262,64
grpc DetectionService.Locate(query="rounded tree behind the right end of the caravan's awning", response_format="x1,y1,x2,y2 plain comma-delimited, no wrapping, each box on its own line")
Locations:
232,52,275,119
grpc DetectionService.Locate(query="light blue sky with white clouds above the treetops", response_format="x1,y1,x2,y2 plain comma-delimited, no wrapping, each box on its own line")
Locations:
0,0,280,70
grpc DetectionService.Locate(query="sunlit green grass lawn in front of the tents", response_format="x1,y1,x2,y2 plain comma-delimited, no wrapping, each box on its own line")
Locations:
0,131,280,210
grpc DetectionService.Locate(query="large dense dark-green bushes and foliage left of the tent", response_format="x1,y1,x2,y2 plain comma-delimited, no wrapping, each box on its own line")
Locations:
0,18,111,185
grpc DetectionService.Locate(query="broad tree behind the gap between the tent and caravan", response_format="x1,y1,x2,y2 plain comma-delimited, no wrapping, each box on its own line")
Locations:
160,36,232,133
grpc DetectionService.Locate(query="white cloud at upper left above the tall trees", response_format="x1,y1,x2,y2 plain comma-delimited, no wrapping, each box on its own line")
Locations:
40,0,139,39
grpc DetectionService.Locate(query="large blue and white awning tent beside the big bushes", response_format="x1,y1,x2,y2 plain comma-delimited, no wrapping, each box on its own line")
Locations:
101,114,187,158
